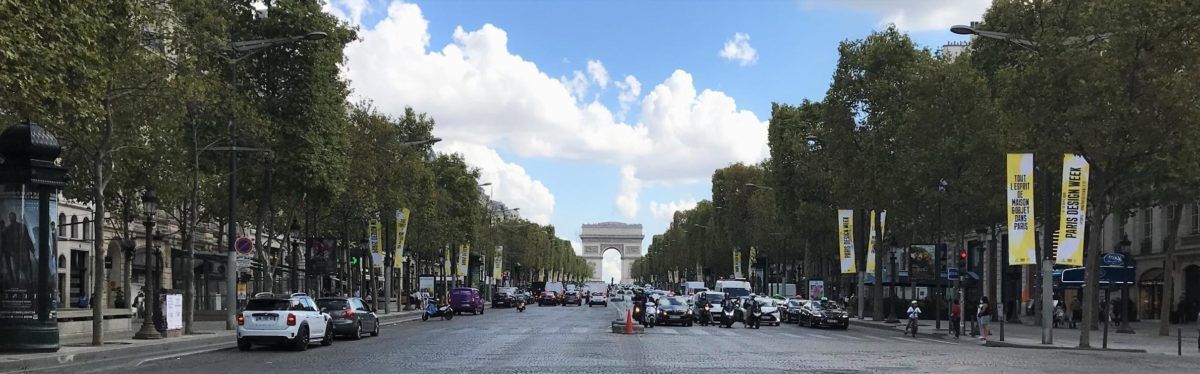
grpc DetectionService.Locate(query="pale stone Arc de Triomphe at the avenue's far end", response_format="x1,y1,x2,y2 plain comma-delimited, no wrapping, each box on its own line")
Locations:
580,222,646,283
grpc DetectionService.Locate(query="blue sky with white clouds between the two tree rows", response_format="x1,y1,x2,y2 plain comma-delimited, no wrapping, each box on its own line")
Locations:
326,0,986,280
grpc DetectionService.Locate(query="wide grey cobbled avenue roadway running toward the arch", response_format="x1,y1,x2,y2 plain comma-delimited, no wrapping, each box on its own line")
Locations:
88,300,1200,373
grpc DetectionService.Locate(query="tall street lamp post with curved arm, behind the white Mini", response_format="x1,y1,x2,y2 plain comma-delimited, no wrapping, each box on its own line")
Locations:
222,31,326,330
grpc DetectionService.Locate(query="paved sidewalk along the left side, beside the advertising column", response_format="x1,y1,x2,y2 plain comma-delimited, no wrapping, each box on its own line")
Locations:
0,310,420,373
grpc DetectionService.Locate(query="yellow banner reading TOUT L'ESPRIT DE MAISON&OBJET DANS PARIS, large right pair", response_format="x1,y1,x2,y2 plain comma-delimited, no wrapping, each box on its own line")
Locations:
1007,153,1037,265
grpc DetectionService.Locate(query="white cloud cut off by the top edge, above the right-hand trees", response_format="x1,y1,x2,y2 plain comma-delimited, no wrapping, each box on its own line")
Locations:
812,0,991,31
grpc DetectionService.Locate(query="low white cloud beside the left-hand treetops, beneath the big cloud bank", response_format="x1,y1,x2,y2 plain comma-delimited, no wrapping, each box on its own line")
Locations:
438,140,554,224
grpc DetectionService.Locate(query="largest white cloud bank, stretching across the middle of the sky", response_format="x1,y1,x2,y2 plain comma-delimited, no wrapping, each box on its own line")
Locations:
334,0,767,217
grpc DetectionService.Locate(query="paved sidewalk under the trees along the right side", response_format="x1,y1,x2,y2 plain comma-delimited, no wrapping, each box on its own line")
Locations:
851,319,1200,357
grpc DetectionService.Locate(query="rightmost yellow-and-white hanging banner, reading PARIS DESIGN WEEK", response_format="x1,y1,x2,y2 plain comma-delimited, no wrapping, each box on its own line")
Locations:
1056,153,1091,266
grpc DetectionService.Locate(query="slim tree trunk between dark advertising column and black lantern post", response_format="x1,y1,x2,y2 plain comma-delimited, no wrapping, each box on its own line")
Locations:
91,157,107,345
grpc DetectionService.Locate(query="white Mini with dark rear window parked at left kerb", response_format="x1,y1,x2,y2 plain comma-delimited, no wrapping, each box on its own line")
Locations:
236,292,334,350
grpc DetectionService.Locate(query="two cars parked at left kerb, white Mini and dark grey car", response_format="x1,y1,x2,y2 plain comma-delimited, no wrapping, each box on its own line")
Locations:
236,292,379,350
